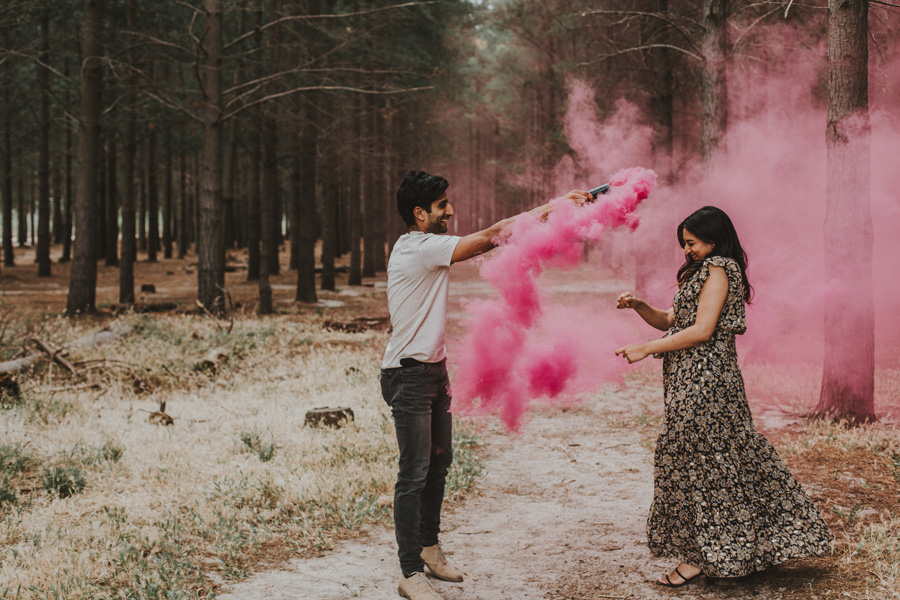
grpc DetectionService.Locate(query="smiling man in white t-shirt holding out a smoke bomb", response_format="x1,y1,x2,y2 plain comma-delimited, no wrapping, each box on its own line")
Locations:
381,171,591,600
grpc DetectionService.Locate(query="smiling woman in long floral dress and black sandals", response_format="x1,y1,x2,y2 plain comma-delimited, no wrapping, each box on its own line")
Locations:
616,206,833,586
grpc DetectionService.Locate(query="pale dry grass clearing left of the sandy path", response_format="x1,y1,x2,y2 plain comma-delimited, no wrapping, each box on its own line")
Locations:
0,315,481,600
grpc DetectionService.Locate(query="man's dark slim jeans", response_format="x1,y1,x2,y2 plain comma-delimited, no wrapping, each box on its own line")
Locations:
381,359,453,575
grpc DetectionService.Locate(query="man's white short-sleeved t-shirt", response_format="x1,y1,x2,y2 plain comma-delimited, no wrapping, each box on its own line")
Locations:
381,231,460,369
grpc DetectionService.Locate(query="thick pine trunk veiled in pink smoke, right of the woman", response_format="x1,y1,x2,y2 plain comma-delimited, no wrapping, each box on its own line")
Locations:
815,0,876,423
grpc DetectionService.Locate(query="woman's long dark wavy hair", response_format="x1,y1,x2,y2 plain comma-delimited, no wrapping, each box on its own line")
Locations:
678,206,753,304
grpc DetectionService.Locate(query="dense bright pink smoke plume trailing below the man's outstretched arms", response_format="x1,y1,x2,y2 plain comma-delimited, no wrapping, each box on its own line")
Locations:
454,168,656,430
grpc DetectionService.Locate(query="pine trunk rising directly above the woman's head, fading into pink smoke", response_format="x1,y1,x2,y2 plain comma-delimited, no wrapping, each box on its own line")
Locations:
700,0,728,169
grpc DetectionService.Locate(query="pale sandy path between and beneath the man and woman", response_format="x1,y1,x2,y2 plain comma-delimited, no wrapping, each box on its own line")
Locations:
213,265,820,600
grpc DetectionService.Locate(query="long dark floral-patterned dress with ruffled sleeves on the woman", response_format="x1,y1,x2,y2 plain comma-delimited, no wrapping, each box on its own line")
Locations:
647,256,833,577
